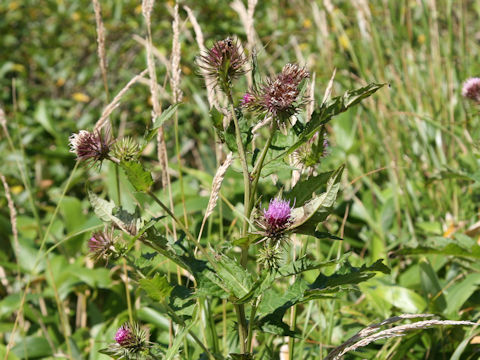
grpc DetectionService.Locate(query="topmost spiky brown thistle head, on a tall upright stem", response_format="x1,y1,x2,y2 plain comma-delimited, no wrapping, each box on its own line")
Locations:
198,38,247,92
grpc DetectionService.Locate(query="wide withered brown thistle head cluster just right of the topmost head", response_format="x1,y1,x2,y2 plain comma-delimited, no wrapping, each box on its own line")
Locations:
246,64,310,120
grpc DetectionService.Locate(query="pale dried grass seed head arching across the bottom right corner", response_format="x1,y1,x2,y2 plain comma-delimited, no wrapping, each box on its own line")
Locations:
325,314,478,360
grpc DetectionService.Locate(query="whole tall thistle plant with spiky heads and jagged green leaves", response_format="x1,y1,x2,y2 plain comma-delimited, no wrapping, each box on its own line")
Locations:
70,32,389,359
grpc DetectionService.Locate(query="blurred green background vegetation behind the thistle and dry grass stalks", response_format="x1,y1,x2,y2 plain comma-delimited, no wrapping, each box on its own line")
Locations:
0,0,480,359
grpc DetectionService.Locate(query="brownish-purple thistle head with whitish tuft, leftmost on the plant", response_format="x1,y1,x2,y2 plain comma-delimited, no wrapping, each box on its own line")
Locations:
69,130,113,164
